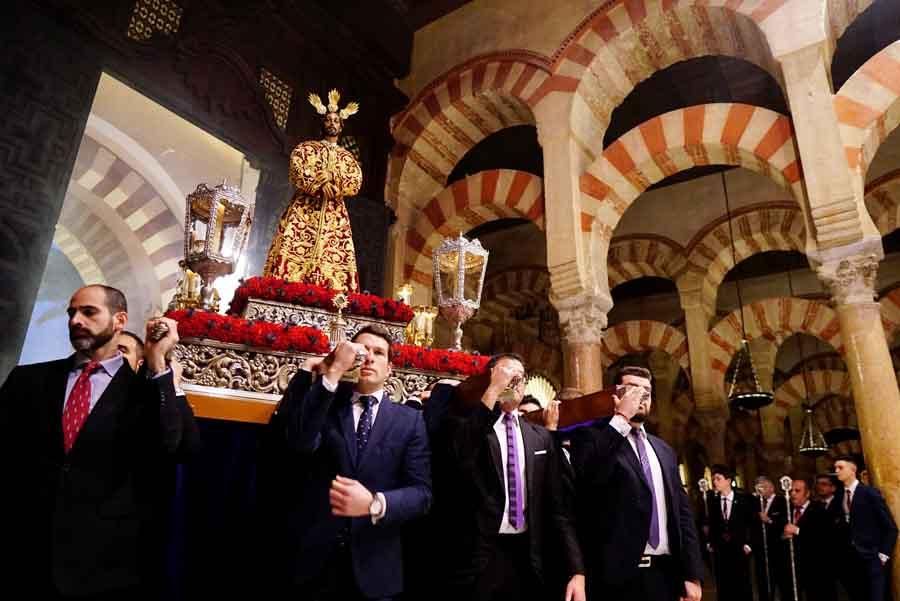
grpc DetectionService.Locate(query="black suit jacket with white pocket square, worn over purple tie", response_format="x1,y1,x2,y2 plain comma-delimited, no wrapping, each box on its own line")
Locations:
436,397,584,585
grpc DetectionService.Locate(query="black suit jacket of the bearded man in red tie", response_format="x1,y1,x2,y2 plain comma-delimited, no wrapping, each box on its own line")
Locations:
0,356,183,595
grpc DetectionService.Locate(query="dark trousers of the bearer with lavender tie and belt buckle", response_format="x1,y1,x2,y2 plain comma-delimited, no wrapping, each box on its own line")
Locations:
587,555,684,601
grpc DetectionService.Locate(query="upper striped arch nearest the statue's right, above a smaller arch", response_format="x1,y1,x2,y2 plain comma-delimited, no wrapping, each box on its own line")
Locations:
385,51,549,208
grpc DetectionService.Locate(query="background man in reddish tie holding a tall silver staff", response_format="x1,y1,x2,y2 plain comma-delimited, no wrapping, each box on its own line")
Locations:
779,479,837,601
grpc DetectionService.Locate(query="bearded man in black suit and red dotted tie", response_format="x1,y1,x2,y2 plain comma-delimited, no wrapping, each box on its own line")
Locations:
0,285,182,599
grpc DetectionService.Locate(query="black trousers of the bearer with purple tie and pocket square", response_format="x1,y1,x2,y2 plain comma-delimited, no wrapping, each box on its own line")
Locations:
470,532,546,601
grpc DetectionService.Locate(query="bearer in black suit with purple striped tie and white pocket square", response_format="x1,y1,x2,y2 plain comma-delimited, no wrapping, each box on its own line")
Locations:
434,353,584,601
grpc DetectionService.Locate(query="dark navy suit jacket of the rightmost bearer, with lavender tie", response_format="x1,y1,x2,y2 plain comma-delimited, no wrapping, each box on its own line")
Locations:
572,418,703,590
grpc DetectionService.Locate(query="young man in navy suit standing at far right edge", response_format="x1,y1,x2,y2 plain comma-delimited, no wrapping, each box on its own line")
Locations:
834,456,897,601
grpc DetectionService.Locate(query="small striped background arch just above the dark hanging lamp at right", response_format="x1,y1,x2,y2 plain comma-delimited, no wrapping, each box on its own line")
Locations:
709,297,844,390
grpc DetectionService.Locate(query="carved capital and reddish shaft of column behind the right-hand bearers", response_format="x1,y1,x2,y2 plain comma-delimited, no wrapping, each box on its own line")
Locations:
554,295,612,398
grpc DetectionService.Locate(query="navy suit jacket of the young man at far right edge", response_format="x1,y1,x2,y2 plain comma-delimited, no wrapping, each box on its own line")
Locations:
831,482,897,559
